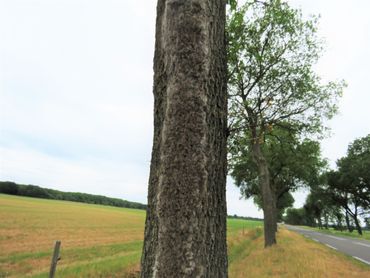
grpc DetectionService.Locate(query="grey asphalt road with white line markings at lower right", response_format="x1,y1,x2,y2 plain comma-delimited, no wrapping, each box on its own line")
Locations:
284,225,370,265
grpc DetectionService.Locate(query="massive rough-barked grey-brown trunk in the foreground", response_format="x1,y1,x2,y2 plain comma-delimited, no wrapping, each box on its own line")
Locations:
141,0,227,277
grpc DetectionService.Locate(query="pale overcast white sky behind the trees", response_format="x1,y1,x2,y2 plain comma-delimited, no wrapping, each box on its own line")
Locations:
0,0,370,217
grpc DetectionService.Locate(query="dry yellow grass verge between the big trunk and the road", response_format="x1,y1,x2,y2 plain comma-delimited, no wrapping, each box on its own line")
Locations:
229,229,370,278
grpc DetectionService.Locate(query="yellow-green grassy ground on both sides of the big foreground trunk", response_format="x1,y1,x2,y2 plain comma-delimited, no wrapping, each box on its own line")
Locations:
0,194,370,277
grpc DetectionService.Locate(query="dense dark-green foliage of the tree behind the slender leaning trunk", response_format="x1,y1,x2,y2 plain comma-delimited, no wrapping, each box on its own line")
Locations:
229,127,326,233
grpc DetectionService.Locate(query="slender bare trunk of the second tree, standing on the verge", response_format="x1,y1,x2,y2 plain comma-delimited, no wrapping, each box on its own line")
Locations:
252,142,276,247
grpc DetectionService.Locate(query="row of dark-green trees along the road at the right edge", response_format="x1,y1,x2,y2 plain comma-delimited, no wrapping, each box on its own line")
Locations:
286,134,370,235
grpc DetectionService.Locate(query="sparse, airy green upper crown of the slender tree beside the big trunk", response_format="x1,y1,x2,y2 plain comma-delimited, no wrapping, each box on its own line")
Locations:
227,0,345,140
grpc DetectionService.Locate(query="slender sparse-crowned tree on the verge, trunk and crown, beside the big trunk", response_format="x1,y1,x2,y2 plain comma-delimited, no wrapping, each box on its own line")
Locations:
227,0,344,246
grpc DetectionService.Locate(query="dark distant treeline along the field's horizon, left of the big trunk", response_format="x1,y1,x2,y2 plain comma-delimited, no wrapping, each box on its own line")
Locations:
0,181,146,209
